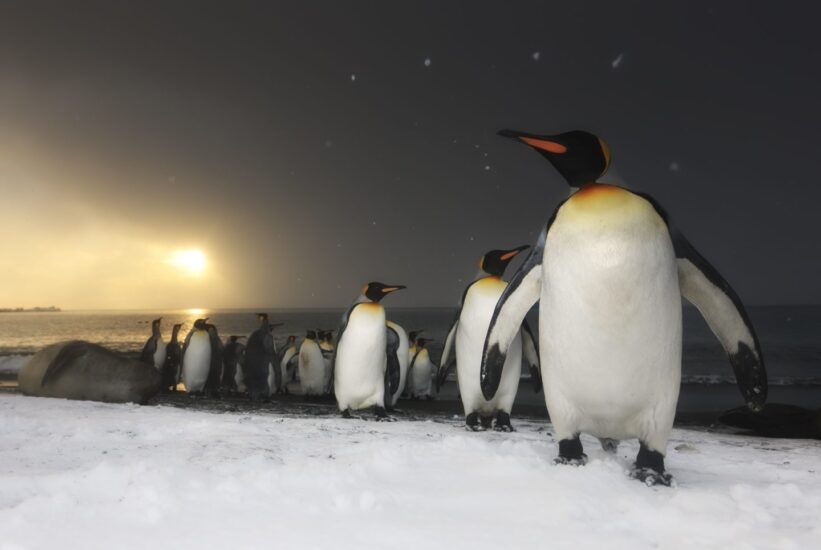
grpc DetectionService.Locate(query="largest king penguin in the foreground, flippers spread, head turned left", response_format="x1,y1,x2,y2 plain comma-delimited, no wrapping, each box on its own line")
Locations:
481,130,767,485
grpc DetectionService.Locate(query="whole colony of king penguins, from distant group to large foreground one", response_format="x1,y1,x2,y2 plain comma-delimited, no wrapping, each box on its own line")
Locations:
141,130,767,486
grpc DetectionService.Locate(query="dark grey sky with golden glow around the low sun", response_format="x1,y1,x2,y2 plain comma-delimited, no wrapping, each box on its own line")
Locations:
0,1,821,307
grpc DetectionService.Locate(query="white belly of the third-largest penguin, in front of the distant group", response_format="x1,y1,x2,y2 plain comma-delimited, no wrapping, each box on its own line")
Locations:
334,304,386,410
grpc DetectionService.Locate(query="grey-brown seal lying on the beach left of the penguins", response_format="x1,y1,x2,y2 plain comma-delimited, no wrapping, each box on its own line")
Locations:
18,340,161,404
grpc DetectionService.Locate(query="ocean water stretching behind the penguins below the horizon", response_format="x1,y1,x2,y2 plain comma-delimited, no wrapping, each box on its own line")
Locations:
0,306,821,416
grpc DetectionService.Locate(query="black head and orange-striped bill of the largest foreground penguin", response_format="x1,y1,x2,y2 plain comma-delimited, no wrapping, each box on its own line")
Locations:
499,130,610,187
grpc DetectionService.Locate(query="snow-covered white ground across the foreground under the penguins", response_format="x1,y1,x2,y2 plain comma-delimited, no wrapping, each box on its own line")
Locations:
0,394,821,550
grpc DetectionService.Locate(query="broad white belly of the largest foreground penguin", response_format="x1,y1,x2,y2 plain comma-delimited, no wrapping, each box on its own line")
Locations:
539,187,681,449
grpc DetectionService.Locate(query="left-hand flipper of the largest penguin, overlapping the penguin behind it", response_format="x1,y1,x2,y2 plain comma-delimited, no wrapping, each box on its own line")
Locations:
480,224,544,400
